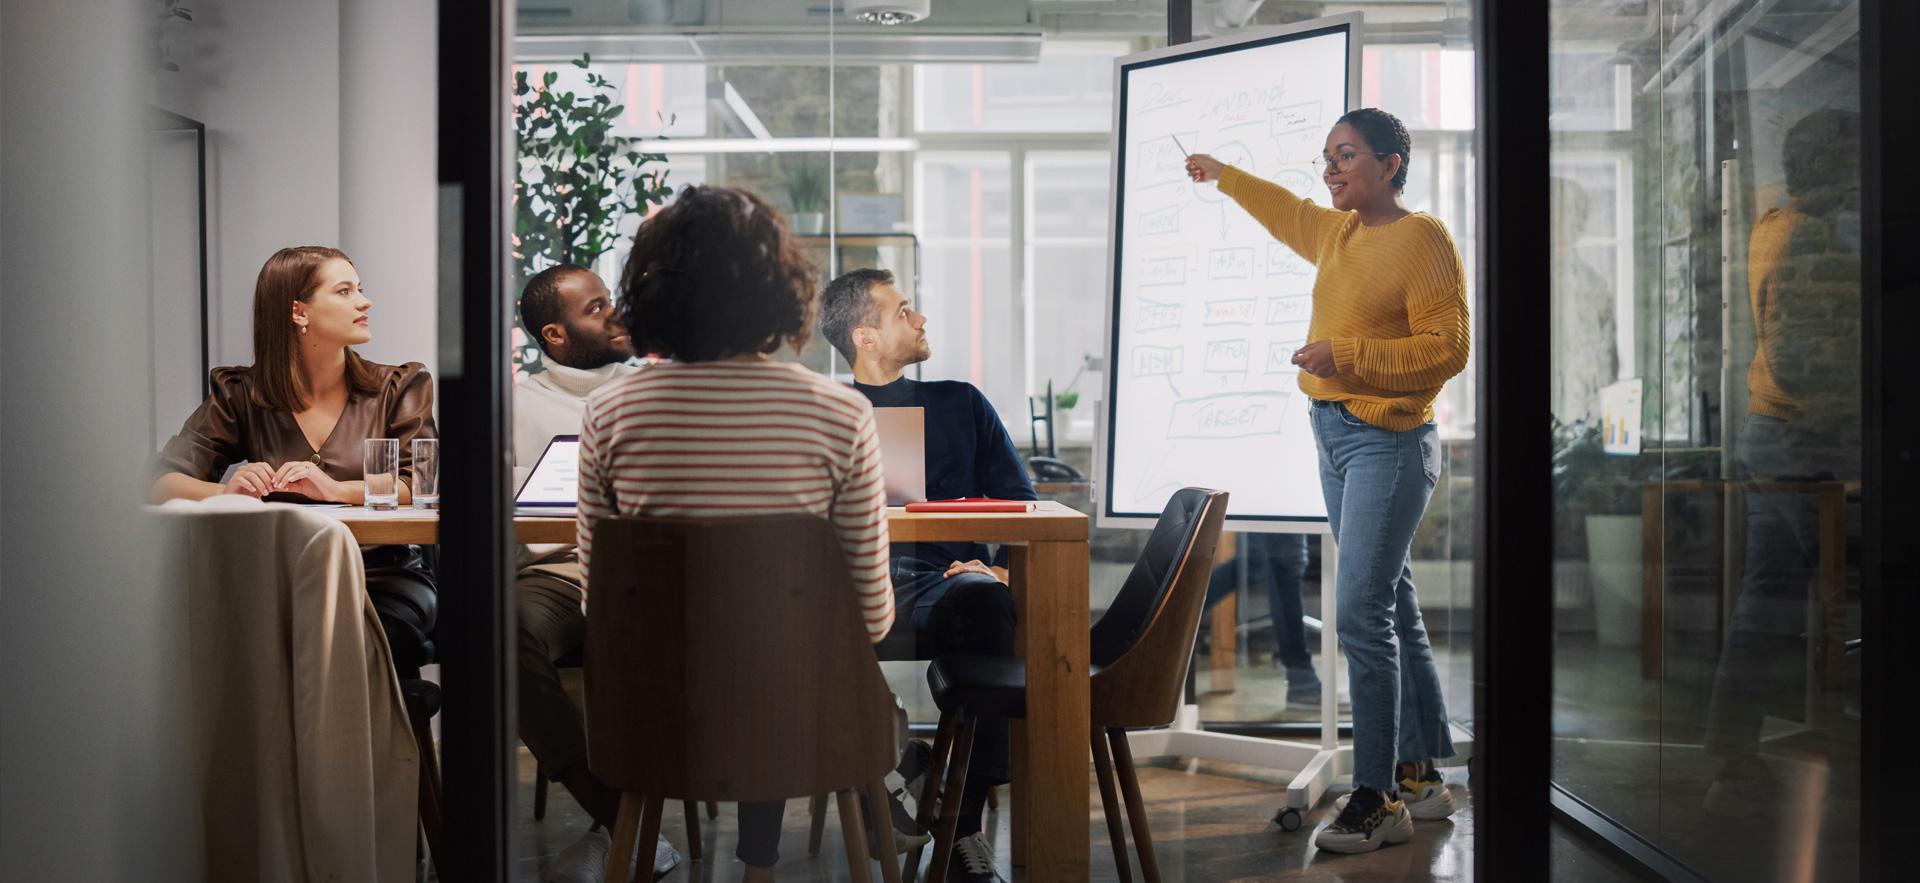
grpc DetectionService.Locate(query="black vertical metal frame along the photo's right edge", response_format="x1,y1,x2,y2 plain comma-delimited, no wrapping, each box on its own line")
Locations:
1860,0,1920,881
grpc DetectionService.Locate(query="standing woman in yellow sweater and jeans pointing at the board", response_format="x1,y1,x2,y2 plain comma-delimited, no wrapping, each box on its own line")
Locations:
1187,107,1469,852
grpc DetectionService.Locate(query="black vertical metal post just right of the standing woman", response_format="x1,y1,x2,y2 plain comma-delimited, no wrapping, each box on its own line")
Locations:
1473,2,1553,879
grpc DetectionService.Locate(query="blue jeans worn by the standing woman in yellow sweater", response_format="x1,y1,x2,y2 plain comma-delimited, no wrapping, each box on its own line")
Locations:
1311,401,1453,793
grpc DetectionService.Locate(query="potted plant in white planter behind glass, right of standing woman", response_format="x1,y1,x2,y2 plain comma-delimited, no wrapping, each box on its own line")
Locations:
1553,420,1644,647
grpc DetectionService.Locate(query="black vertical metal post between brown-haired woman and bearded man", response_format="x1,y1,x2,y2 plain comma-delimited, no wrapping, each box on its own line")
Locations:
436,0,518,881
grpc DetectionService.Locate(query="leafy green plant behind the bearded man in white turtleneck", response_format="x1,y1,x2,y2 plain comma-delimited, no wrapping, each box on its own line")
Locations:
513,54,672,372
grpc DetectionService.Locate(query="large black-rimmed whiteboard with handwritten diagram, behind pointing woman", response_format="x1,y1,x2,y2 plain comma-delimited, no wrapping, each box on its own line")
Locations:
1094,13,1359,532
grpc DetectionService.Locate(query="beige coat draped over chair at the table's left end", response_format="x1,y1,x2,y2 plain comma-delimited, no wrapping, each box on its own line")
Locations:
159,495,420,883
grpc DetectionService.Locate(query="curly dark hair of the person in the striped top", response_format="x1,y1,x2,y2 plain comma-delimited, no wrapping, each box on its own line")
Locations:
620,184,820,363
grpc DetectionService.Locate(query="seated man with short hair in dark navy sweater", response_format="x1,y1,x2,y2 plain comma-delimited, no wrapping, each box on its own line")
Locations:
820,269,1037,883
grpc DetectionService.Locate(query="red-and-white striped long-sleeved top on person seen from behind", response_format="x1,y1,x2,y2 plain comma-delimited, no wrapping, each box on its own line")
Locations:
576,361,893,643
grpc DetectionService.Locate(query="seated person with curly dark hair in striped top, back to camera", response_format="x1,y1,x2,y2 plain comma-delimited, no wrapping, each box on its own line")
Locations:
576,186,893,883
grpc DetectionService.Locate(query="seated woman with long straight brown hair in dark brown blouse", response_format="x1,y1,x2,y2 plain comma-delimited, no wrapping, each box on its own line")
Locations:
150,246,438,678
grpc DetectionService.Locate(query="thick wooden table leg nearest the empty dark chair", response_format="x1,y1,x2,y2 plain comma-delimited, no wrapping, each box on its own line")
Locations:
1012,541,1092,881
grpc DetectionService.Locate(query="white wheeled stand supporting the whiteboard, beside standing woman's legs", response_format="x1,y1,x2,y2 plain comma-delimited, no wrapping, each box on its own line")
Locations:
1127,524,1473,831
